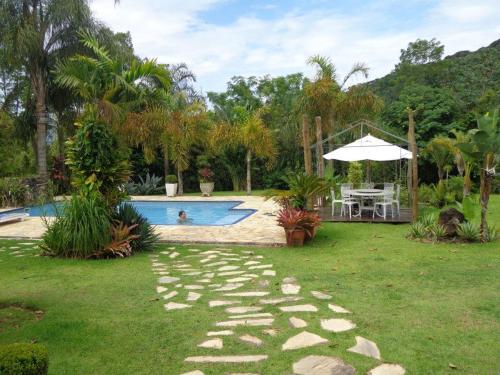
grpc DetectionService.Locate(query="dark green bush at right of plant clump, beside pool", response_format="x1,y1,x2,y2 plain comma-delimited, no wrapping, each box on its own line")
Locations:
113,203,158,252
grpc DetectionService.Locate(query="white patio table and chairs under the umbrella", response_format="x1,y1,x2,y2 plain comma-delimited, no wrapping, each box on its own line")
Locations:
330,182,401,220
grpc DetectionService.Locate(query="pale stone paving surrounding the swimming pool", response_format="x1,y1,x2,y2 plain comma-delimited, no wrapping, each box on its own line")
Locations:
0,195,286,246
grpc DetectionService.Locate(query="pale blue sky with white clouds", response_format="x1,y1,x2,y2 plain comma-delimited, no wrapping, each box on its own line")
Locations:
91,0,500,93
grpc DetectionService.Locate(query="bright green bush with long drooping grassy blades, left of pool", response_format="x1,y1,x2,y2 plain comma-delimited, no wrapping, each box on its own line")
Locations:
40,194,112,258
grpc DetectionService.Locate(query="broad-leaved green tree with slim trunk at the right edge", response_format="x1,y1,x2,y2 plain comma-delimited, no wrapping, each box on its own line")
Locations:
457,109,500,242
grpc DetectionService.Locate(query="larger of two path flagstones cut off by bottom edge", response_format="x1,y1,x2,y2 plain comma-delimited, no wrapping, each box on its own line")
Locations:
293,355,356,375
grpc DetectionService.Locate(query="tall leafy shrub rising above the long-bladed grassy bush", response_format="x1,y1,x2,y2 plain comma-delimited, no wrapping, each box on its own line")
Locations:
66,120,130,209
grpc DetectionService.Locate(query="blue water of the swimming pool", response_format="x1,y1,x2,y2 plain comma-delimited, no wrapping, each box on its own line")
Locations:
11,201,256,225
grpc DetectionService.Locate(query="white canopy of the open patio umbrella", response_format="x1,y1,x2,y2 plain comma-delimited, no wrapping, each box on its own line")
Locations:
323,134,412,161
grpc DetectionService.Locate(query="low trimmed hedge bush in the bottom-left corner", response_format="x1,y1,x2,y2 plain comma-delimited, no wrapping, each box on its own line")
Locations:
0,344,49,375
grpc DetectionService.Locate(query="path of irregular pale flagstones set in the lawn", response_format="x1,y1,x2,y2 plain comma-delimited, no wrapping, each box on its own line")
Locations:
150,247,405,375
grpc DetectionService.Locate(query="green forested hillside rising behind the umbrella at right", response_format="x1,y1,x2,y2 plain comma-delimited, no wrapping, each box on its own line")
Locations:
366,39,500,146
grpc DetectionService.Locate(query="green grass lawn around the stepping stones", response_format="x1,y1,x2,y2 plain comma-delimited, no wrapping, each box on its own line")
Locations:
0,196,500,375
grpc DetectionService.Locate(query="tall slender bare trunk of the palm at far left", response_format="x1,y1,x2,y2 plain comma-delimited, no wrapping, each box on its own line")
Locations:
31,68,48,195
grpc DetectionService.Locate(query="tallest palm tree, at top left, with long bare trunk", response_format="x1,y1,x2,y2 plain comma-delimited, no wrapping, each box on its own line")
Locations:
0,0,93,192
